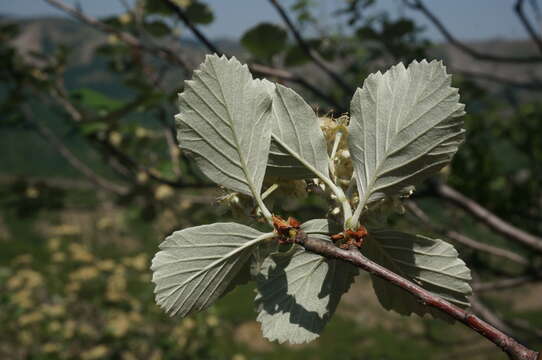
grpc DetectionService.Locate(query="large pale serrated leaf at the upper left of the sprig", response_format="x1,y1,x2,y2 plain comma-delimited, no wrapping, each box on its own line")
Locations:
175,55,271,198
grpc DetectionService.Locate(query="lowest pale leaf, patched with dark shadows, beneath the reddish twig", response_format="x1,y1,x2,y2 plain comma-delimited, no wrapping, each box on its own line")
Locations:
256,219,358,344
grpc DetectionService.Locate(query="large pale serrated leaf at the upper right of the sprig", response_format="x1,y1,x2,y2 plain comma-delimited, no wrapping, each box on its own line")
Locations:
349,60,465,211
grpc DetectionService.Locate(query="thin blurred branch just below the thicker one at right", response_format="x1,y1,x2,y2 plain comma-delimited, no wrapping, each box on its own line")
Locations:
404,200,529,265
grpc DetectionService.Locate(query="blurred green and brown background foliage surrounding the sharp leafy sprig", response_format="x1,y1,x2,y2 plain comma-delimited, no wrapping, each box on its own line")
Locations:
0,0,542,360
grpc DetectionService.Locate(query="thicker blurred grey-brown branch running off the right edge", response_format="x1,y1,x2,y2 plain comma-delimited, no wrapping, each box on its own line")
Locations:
434,183,542,253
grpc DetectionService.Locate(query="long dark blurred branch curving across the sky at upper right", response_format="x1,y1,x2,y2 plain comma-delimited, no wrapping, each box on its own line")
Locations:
403,0,542,64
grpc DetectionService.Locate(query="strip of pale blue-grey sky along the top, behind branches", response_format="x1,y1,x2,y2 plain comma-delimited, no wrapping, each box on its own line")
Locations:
0,0,540,41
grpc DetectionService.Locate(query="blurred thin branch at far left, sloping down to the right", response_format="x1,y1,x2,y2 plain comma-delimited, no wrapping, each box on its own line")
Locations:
21,106,129,195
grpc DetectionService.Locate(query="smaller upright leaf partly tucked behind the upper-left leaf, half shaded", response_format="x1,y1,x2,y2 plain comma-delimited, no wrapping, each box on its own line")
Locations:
266,84,329,179
